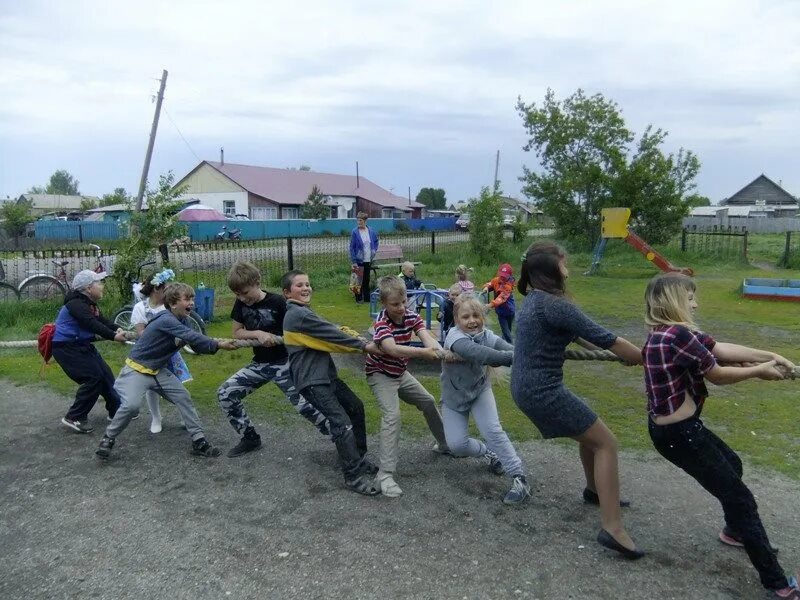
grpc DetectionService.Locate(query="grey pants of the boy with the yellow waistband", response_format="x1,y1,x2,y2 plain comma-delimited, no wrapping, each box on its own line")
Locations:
106,365,205,440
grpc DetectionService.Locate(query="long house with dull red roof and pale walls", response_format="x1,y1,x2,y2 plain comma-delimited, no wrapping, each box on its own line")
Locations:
176,160,425,220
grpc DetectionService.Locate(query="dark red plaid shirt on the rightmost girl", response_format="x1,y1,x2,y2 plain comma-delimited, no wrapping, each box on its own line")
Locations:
642,325,717,417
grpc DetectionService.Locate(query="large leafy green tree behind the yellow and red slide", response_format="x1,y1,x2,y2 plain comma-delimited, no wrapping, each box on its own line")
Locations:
517,89,700,246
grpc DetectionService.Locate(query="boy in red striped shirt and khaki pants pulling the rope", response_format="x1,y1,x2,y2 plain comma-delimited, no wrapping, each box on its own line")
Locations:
365,276,449,497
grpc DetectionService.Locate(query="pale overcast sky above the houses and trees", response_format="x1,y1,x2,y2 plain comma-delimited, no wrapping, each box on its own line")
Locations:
0,0,800,201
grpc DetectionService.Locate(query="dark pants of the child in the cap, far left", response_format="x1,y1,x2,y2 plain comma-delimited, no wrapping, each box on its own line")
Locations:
53,343,120,421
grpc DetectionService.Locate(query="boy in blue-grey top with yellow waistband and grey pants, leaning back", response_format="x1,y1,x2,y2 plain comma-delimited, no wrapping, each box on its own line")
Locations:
95,283,237,458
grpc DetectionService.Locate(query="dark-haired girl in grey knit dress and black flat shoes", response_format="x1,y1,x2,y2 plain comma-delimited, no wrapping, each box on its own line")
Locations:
511,241,644,559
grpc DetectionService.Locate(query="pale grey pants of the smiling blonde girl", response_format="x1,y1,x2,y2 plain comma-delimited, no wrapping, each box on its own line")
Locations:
442,388,525,477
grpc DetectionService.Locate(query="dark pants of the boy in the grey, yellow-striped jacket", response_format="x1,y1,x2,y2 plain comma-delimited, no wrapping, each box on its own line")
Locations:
300,378,367,481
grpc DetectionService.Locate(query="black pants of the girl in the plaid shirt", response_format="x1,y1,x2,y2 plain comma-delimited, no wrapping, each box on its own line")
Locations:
648,417,788,590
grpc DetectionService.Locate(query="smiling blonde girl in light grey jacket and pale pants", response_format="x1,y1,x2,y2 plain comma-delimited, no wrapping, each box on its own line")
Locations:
441,295,531,504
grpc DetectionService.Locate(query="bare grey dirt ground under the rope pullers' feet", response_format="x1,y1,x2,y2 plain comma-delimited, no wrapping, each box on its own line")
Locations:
0,380,800,600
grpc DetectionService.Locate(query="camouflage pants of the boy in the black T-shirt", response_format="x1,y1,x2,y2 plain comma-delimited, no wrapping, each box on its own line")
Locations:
217,360,330,435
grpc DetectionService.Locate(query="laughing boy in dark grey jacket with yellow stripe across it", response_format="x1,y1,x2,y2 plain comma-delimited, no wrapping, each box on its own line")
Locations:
281,270,380,496
